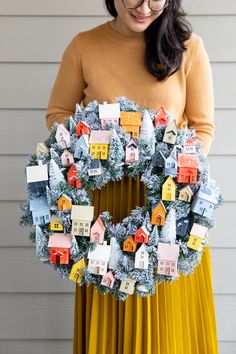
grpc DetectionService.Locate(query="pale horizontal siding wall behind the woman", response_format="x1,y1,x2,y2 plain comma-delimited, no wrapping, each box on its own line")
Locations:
0,0,236,354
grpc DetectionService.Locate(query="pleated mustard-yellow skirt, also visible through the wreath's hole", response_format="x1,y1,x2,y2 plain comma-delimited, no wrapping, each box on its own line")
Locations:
73,178,218,354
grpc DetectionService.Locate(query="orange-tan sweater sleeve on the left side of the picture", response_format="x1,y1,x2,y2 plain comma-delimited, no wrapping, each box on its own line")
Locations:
46,36,86,129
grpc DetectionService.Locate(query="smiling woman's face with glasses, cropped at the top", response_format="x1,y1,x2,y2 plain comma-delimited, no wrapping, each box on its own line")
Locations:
114,0,165,35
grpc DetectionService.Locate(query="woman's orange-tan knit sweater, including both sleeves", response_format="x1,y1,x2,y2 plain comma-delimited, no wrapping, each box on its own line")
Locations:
46,22,214,153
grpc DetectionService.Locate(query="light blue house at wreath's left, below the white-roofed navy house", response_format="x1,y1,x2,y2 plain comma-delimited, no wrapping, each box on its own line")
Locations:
30,196,51,225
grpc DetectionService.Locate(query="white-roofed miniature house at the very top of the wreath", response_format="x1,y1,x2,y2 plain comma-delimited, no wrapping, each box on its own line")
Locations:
98,102,120,129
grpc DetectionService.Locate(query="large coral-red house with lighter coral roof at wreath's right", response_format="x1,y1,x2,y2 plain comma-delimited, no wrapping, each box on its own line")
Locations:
177,154,199,183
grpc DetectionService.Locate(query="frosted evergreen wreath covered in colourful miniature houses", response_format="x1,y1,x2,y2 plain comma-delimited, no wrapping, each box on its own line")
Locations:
20,97,222,300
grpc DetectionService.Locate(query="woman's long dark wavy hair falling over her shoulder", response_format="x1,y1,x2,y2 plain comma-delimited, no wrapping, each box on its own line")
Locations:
105,0,192,81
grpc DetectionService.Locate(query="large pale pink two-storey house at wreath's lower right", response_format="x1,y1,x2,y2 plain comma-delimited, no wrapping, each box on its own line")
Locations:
157,242,179,276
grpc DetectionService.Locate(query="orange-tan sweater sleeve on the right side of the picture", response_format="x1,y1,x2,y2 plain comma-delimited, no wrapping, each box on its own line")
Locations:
185,36,214,154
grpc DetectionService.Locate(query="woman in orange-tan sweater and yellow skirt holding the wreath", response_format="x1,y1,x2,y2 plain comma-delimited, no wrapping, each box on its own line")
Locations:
46,0,218,354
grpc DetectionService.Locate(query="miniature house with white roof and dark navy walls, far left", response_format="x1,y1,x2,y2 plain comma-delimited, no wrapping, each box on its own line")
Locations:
26,160,48,194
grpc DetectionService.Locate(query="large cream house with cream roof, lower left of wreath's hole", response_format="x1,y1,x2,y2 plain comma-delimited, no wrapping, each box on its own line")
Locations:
71,205,94,237
